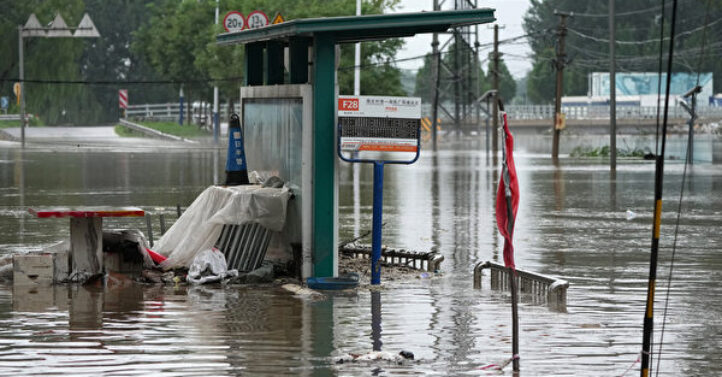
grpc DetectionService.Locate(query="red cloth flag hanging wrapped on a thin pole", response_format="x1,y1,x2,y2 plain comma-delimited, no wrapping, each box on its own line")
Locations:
496,111,519,269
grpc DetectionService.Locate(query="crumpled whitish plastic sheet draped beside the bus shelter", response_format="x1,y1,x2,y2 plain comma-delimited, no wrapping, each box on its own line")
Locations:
154,186,291,269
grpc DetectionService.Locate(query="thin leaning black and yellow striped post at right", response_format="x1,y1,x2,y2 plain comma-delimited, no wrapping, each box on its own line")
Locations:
640,0,677,377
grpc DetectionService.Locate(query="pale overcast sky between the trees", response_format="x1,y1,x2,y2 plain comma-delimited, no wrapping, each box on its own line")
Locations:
396,0,531,79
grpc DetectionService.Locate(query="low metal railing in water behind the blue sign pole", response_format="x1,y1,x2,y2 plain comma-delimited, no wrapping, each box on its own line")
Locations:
339,245,444,272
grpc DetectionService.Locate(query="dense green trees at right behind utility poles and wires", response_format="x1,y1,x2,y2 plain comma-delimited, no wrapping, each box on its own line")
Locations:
524,0,722,103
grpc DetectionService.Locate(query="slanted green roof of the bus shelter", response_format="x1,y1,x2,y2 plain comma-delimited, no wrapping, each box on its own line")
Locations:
216,8,496,44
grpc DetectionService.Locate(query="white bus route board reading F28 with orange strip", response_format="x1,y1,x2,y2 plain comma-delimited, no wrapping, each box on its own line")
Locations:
338,96,421,158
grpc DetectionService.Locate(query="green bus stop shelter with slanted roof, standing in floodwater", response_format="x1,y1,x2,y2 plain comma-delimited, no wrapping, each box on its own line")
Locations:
216,8,495,278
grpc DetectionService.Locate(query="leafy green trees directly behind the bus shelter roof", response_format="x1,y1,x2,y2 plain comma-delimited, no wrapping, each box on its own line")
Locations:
132,0,404,100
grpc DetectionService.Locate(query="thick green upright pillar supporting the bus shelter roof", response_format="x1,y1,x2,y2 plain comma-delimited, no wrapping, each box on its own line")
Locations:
312,33,336,276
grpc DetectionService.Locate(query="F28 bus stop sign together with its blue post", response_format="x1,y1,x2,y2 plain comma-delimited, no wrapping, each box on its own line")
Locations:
338,96,421,285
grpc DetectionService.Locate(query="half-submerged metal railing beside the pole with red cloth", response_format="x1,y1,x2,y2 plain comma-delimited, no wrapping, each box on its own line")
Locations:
474,261,569,310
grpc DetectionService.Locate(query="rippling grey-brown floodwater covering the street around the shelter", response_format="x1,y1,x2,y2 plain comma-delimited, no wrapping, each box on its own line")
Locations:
0,137,722,376
